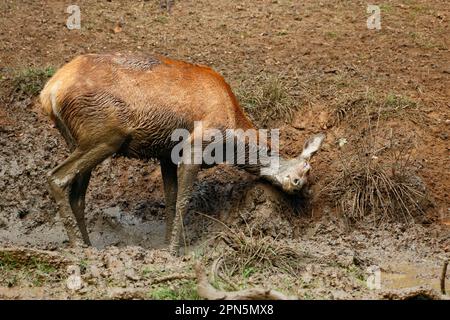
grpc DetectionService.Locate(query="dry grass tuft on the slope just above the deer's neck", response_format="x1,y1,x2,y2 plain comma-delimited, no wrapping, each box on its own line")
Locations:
237,76,298,127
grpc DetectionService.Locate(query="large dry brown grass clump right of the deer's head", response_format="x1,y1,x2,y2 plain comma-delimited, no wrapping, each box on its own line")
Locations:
323,126,429,224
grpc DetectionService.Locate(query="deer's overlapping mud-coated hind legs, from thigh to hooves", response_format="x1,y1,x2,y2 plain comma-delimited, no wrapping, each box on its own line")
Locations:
48,139,123,246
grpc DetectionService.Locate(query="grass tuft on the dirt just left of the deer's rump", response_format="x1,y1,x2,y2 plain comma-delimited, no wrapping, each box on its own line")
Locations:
10,67,55,100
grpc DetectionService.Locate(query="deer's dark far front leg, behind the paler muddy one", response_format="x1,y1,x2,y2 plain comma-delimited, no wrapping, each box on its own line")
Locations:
161,158,178,242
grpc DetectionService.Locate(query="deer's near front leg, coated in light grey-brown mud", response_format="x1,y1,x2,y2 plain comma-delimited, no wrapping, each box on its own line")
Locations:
169,163,201,255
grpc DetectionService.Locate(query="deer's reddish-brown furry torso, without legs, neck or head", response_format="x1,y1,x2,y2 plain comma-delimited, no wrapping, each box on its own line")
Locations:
40,54,253,157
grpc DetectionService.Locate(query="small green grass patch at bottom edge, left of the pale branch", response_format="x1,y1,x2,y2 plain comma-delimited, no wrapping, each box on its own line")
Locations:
149,280,200,300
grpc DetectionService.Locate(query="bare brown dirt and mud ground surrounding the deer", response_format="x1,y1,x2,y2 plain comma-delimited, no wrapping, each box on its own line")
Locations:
0,0,450,299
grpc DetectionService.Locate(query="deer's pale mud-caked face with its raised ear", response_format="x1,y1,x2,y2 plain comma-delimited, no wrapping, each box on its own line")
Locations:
279,134,325,193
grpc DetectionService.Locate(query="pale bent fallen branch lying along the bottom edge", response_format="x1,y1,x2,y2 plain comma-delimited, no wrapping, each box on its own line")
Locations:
195,262,297,300
